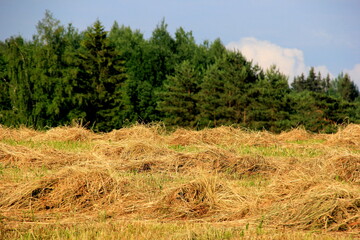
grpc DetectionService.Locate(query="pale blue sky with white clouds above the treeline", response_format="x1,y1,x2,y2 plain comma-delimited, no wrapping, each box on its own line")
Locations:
0,0,360,87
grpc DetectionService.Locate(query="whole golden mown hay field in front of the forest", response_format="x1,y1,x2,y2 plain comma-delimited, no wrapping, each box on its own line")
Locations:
0,125,360,239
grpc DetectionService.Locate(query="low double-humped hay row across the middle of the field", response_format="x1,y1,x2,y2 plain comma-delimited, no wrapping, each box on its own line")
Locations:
94,140,276,175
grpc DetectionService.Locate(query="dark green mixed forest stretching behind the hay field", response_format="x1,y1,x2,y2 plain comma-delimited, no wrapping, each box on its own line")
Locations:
0,11,360,133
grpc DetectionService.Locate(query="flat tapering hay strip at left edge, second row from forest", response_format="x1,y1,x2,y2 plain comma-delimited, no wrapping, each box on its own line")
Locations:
0,143,89,168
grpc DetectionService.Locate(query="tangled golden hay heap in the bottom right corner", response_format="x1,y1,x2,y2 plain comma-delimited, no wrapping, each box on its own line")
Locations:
270,182,360,231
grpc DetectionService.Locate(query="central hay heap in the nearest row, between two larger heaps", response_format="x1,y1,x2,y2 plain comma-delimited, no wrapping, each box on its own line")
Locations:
155,177,249,219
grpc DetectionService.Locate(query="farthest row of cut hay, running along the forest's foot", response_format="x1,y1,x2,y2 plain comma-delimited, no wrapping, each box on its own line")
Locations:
0,124,360,146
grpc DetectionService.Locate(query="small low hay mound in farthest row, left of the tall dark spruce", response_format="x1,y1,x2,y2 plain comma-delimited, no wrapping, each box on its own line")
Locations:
31,127,97,141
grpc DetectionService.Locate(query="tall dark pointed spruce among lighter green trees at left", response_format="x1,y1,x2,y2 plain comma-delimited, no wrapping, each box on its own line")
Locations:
77,20,125,131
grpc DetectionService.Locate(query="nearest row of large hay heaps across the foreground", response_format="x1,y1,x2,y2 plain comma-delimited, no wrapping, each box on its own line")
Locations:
0,158,359,230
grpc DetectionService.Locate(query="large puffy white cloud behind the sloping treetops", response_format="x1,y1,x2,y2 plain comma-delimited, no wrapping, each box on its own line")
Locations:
226,38,332,82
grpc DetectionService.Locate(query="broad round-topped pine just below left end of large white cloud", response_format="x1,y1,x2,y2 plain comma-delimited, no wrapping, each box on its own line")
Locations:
198,52,256,126
